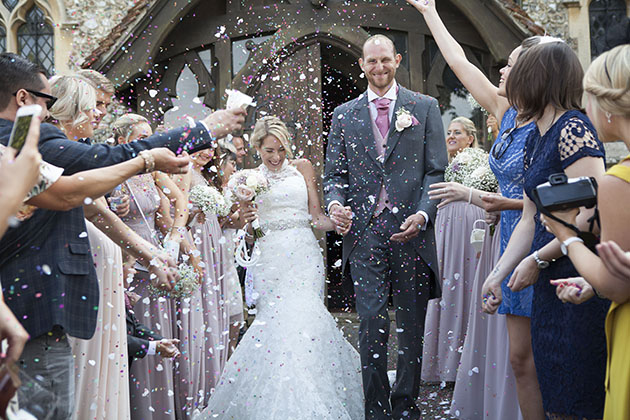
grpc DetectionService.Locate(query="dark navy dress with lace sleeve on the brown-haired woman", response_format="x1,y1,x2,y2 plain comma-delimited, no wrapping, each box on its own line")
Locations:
524,111,610,419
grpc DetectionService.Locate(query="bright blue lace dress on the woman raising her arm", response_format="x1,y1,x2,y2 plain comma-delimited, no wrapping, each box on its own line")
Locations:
490,108,536,317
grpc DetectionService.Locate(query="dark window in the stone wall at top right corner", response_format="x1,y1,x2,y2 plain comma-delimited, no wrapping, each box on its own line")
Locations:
588,0,630,58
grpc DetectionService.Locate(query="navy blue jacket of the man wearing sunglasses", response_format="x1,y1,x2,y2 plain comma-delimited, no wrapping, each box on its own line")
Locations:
0,119,212,339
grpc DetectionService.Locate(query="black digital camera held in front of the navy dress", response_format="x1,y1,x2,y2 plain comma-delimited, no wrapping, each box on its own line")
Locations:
534,173,597,212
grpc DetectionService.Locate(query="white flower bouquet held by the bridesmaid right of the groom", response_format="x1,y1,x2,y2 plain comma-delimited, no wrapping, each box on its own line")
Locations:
444,147,499,192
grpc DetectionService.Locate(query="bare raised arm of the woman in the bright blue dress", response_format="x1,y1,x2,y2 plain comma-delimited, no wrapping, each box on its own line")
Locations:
407,0,510,121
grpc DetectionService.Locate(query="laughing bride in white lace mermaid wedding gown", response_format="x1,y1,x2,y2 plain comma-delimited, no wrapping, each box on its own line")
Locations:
197,116,364,420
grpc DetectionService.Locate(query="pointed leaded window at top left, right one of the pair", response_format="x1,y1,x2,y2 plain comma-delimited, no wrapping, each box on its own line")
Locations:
18,6,55,74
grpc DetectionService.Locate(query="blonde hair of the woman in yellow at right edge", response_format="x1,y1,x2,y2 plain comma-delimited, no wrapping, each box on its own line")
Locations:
583,44,630,117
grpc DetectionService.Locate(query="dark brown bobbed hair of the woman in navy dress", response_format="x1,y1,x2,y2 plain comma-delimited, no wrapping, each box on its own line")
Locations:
506,42,584,121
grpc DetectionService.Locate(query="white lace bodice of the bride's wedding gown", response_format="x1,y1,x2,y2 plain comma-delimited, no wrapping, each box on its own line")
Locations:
258,160,311,230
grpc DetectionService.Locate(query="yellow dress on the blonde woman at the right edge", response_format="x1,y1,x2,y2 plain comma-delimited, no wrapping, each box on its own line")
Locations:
604,156,630,420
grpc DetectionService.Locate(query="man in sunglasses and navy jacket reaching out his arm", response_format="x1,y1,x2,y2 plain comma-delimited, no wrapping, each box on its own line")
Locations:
0,53,245,419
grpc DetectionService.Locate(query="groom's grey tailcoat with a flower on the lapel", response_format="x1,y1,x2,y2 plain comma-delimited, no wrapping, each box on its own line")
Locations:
324,86,448,276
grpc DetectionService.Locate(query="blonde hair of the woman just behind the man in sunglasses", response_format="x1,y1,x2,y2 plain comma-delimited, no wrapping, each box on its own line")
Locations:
50,74,96,127
